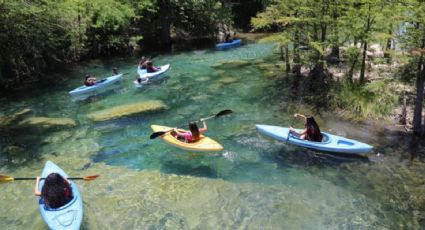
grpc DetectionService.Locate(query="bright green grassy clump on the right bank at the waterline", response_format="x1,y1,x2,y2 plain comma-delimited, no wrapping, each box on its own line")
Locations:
330,81,398,119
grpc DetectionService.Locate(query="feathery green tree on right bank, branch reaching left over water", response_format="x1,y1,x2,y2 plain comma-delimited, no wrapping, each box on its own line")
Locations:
252,0,338,81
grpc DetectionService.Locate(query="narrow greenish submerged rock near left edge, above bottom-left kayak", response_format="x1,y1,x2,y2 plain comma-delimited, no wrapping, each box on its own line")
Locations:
18,117,77,129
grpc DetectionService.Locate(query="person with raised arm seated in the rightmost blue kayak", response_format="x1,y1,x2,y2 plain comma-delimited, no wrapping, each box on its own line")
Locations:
289,113,323,142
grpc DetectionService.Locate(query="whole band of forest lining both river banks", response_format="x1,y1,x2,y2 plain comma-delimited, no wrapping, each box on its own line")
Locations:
0,0,425,136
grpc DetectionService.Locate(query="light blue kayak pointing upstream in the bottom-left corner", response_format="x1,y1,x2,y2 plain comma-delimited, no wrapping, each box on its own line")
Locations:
38,161,83,230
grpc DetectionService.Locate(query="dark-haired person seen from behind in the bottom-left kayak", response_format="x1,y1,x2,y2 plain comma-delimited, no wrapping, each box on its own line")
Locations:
34,173,73,208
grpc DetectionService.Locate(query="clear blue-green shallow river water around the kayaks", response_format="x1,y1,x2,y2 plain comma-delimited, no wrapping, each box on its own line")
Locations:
0,44,425,229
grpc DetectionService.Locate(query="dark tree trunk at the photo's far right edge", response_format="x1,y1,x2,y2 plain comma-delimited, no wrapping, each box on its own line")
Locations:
413,54,425,136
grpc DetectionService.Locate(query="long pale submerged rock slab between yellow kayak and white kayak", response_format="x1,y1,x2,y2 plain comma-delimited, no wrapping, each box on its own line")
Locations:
87,100,167,121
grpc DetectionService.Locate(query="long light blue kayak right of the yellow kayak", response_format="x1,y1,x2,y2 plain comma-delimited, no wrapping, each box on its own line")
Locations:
255,125,373,154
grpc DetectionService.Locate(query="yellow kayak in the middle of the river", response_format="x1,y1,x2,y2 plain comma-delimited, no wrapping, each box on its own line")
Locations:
151,125,223,151
